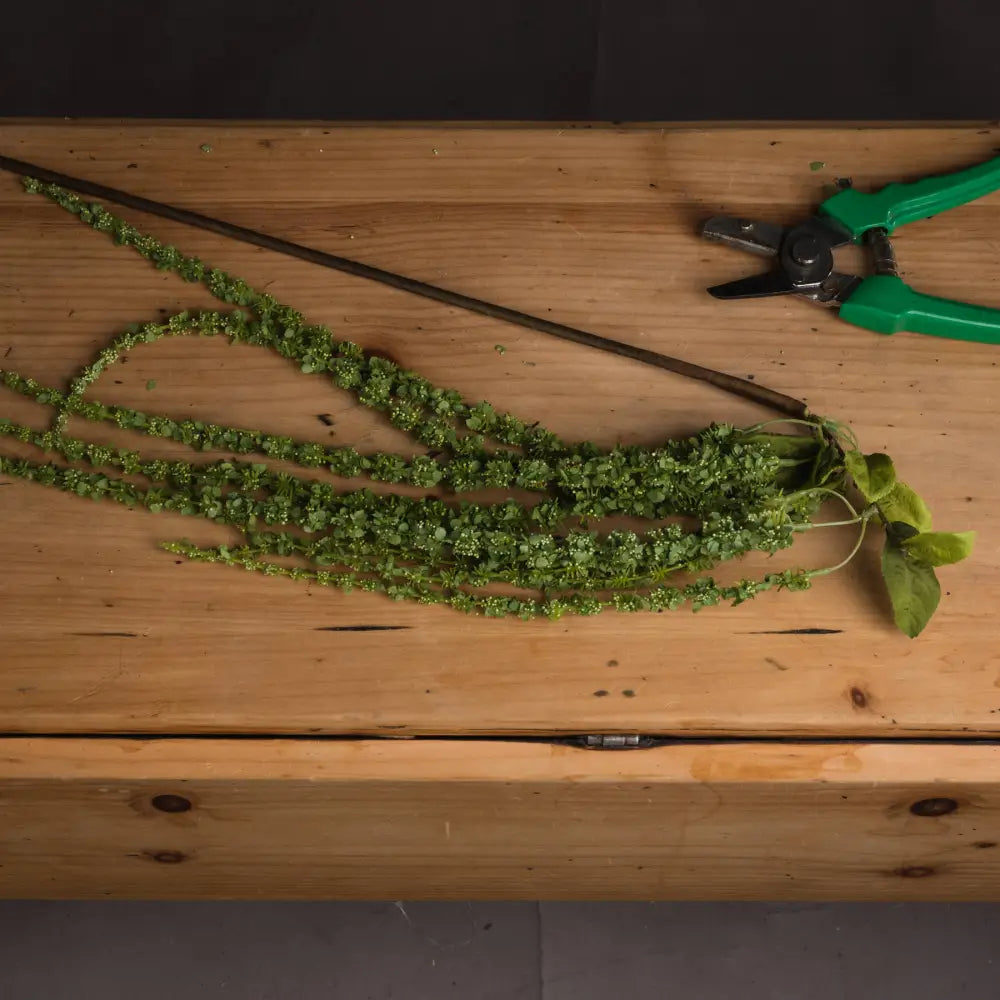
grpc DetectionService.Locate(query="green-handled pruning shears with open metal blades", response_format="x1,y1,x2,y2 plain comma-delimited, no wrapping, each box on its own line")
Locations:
702,157,1000,344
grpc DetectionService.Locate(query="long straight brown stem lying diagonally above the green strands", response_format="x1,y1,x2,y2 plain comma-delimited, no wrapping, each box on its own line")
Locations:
0,156,808,418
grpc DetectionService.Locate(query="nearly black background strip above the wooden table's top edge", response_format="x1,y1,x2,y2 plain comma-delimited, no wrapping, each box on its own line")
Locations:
0,0,1000,121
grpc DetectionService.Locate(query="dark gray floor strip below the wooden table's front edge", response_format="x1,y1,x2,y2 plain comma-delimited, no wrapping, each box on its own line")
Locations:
0,902,1000,1000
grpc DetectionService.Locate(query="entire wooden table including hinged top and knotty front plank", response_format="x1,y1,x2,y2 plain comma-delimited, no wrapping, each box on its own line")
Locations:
0,122,1000,899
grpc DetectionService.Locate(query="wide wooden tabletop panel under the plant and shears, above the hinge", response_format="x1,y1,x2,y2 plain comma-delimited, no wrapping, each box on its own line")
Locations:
0,122,1000,735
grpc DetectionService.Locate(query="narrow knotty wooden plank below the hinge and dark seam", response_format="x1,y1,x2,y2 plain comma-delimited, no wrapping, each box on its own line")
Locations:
0,738,1000,900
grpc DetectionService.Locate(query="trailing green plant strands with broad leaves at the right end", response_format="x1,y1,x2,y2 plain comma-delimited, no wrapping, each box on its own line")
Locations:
0,179,972,632
